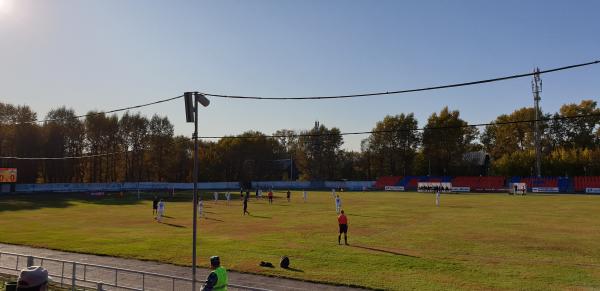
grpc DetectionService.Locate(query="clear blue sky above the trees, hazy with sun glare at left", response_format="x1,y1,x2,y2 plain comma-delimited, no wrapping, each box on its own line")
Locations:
0,0,600,149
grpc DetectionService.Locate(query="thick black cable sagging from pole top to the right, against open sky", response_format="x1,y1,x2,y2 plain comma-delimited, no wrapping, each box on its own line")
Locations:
201,60,600,100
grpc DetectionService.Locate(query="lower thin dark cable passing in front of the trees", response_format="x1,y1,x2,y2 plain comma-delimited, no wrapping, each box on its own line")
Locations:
0,113,600,160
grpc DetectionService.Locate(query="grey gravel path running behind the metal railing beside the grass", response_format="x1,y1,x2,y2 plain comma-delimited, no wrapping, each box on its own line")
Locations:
0,243,360,291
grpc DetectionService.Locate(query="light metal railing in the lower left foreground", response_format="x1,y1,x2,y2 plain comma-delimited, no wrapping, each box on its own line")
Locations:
0,252,269,291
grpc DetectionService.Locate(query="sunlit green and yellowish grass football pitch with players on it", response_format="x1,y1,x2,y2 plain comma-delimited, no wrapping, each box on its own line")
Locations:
0,192,600,290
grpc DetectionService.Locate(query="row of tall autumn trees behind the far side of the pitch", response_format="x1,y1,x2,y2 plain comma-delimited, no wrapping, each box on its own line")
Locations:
0,100,600,183
